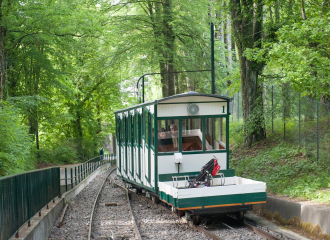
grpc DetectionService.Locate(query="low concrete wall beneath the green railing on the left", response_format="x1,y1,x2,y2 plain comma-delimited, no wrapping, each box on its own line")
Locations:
20,163,110,240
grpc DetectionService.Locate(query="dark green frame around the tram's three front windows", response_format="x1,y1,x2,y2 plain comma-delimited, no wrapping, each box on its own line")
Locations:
155,114,229,156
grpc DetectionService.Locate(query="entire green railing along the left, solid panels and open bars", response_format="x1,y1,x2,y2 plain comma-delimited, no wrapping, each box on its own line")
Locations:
0,154,116,239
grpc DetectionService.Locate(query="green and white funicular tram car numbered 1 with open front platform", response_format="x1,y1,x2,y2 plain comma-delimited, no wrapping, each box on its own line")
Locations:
115,92,267,223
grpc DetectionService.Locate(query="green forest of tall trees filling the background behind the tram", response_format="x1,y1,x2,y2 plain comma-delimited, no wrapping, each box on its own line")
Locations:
0,0,330,176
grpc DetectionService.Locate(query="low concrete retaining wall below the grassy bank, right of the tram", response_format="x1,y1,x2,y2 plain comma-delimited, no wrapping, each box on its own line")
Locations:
259,197,330,235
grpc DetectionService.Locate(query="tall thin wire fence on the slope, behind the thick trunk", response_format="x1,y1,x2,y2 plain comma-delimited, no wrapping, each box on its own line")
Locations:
231,84,330,163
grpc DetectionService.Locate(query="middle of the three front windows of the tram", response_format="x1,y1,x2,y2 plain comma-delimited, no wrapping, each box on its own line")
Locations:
182,118,203,152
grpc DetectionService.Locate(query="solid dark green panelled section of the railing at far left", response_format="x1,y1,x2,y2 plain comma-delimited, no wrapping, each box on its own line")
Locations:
0,167,60,239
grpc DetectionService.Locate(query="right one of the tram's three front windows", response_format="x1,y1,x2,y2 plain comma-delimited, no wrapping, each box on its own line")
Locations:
205,118,226,151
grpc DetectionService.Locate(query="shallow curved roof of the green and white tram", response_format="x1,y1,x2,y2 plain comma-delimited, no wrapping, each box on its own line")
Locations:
114,91,232,113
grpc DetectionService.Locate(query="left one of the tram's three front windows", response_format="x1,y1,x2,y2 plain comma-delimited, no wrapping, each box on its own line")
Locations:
157,119,179,152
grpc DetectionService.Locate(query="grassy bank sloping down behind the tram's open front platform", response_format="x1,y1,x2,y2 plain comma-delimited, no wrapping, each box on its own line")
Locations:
230,122,330,203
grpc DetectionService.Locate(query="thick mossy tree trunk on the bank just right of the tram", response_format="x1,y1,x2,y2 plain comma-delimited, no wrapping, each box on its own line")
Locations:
230,0,265,147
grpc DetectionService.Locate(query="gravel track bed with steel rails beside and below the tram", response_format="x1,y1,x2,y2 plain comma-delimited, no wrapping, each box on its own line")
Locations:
50,169,287,240
